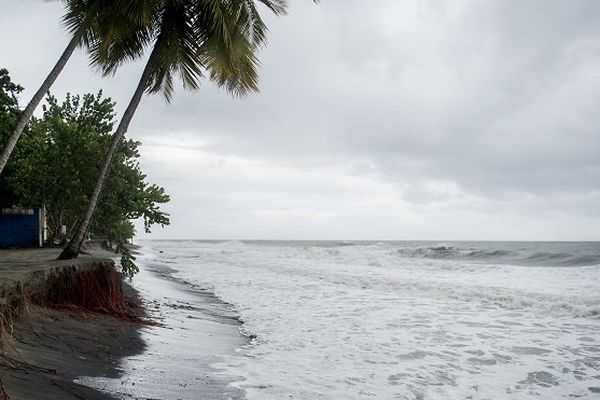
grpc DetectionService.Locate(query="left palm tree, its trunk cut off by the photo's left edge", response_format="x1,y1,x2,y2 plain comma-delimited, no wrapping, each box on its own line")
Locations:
0,0,158,174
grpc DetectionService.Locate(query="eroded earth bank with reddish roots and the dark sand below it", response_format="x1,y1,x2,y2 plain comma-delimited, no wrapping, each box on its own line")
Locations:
0,249,145,400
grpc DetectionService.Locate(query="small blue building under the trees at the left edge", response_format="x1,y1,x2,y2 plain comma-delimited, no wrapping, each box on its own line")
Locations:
0,208,45,247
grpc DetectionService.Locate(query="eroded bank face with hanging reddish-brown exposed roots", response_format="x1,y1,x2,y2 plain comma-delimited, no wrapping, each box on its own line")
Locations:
0,261,153,400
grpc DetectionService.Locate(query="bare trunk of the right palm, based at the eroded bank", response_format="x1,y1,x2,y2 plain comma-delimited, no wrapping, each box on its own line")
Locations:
58,46,157,260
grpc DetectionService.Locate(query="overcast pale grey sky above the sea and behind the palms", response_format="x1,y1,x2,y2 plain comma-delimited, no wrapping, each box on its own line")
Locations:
0,0,600,240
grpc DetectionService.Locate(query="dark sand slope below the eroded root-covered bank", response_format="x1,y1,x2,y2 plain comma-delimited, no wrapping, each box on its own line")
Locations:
0,288,145,400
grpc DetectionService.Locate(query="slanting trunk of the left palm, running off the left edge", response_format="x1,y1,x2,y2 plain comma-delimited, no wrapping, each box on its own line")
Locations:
0,35,79,174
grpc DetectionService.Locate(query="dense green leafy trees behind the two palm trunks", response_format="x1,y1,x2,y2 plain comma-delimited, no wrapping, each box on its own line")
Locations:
0,70,169,275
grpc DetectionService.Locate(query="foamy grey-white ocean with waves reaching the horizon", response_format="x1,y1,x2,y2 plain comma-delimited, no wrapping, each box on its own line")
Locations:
91,241,600,400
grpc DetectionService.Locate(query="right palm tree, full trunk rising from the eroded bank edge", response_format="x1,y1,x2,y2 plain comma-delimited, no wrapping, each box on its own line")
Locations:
59,0,285,259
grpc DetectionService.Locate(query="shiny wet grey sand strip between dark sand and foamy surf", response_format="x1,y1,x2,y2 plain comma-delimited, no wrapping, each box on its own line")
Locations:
77,264,249,400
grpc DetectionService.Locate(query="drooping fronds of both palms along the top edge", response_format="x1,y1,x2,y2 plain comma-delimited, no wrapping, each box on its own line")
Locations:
81,0,286,100
